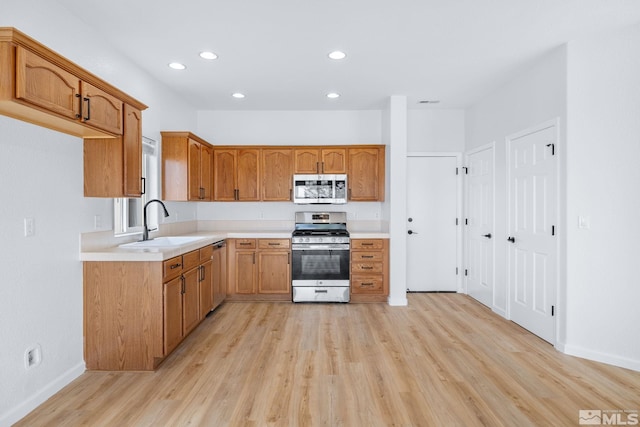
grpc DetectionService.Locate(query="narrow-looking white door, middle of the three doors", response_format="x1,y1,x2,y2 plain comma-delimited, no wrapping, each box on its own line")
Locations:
465,145,495,307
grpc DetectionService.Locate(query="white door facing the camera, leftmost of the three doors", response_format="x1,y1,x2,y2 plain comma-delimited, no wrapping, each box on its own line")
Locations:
407,156,458,292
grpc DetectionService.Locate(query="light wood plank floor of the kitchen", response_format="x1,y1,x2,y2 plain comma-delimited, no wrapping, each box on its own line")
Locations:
17,294,640,427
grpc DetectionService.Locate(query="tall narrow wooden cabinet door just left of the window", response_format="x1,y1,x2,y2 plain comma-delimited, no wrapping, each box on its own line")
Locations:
122,104,143,197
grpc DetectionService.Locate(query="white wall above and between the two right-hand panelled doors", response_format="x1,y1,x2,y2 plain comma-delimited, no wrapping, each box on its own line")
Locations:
466,47,566,316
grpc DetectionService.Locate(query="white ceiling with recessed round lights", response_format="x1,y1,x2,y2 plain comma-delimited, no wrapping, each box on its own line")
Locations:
58,0,640,110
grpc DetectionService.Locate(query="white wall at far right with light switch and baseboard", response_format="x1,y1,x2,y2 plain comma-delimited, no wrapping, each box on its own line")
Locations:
565,25,640,370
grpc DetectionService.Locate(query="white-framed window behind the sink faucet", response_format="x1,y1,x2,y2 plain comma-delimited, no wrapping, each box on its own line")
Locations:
113,136,158,236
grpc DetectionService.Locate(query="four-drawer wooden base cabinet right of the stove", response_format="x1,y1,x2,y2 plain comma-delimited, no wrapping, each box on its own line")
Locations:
351,239,389,302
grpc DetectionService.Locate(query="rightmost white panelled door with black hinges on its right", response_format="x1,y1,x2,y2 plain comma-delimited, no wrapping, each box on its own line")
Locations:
507,125,558,343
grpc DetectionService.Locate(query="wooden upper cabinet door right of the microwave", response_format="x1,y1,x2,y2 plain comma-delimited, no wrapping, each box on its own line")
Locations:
348,148,384,201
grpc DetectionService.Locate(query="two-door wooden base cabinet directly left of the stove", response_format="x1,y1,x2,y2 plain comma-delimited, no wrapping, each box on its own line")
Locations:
227,239,291,301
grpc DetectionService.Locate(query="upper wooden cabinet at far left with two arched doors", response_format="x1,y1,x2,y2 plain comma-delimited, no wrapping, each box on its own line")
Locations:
0,27,147,138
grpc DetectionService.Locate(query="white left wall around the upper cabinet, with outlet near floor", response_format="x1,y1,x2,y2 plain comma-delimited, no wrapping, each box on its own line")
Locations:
0,0,196,426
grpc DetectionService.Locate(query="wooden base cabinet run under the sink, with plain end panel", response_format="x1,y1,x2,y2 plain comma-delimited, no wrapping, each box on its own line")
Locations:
83,245,226,371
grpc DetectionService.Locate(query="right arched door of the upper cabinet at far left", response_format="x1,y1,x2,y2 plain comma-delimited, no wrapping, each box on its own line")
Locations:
80,82,124,135
